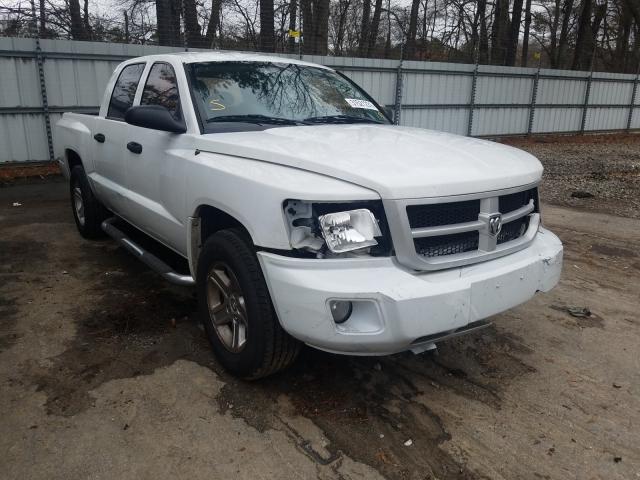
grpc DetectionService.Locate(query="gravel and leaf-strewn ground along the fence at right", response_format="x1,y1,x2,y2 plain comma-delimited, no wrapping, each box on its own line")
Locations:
504,134,640,218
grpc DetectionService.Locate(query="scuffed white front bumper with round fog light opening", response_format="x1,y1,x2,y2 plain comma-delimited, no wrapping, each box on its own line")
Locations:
258,228,562,355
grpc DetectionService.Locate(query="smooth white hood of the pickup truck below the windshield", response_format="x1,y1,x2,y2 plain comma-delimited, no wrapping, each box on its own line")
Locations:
196,124,542,199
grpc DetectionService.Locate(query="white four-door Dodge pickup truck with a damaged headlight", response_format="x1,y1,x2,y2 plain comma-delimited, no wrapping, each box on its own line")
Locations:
55,52,562,378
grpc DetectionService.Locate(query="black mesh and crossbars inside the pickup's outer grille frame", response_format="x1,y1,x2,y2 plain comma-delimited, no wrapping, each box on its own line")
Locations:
405,187,539,268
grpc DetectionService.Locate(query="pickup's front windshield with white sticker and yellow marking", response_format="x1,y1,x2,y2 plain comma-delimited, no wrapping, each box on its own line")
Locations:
187,62,389,131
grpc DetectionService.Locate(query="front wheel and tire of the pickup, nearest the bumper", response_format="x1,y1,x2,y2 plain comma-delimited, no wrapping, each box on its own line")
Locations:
196,229,300,380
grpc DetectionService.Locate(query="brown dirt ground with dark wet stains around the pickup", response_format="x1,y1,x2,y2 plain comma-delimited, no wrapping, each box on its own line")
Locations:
0,144,640,480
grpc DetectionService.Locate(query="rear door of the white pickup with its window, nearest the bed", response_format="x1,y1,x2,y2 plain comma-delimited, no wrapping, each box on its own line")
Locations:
89,62,145,214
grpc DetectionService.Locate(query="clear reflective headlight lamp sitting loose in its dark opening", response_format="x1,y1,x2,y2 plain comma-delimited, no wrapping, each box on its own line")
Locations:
318,208,382,253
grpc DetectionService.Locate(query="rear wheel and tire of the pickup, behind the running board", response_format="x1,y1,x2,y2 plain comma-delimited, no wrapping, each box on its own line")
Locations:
69,165,108,239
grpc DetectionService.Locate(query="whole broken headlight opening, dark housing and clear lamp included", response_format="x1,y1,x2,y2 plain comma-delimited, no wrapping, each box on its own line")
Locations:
284,200,391,257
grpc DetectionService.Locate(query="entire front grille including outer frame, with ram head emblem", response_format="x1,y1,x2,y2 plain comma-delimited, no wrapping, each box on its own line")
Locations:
385,185,540,270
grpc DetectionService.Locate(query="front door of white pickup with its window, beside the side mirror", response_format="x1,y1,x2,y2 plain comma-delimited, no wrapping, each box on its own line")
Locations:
122,61,188,253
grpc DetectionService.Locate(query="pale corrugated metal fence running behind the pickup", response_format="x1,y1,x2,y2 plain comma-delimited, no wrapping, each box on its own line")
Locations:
0,38,640,162
